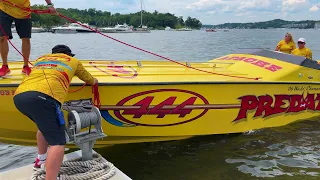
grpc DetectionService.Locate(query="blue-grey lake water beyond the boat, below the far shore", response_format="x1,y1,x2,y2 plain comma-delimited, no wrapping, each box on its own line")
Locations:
9,30,320,61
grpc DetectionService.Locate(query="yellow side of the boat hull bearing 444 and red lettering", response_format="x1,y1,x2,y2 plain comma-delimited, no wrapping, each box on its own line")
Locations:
0,82,320,147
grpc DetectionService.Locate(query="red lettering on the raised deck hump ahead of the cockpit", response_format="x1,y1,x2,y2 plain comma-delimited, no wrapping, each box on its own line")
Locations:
218,56,282,72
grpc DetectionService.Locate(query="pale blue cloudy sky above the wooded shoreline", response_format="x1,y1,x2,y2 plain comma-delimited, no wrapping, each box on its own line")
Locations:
31,0,320,24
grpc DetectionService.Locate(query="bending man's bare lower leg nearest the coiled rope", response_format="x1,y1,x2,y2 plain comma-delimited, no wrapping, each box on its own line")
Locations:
46,146,64,180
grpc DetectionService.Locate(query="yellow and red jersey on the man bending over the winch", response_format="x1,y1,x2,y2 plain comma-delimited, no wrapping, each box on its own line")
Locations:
15,53,94,104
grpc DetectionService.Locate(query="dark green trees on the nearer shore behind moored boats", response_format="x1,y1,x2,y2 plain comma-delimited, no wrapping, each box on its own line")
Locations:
31,5,202,29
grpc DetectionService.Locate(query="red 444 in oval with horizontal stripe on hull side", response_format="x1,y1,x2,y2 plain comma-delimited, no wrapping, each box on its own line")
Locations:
100,89,239,127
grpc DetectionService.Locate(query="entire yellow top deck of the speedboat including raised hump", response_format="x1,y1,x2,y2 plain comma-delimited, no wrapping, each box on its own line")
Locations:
0,50,320,86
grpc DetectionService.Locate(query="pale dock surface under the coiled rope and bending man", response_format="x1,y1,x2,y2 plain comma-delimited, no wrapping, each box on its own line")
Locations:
0,150,132,180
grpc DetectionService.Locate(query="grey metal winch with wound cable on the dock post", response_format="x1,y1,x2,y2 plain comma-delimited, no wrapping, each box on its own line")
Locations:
63,99,106,161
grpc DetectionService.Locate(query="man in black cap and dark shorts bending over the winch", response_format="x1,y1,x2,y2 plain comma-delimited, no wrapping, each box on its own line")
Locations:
14,45,98,180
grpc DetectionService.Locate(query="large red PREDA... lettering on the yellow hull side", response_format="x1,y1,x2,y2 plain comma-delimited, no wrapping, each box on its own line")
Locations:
234,94,320,122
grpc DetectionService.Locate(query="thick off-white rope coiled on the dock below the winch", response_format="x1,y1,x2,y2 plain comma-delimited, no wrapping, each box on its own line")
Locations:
31,153,116,180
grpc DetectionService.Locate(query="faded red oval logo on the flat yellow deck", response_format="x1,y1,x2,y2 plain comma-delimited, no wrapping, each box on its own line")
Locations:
89,62,138,79
